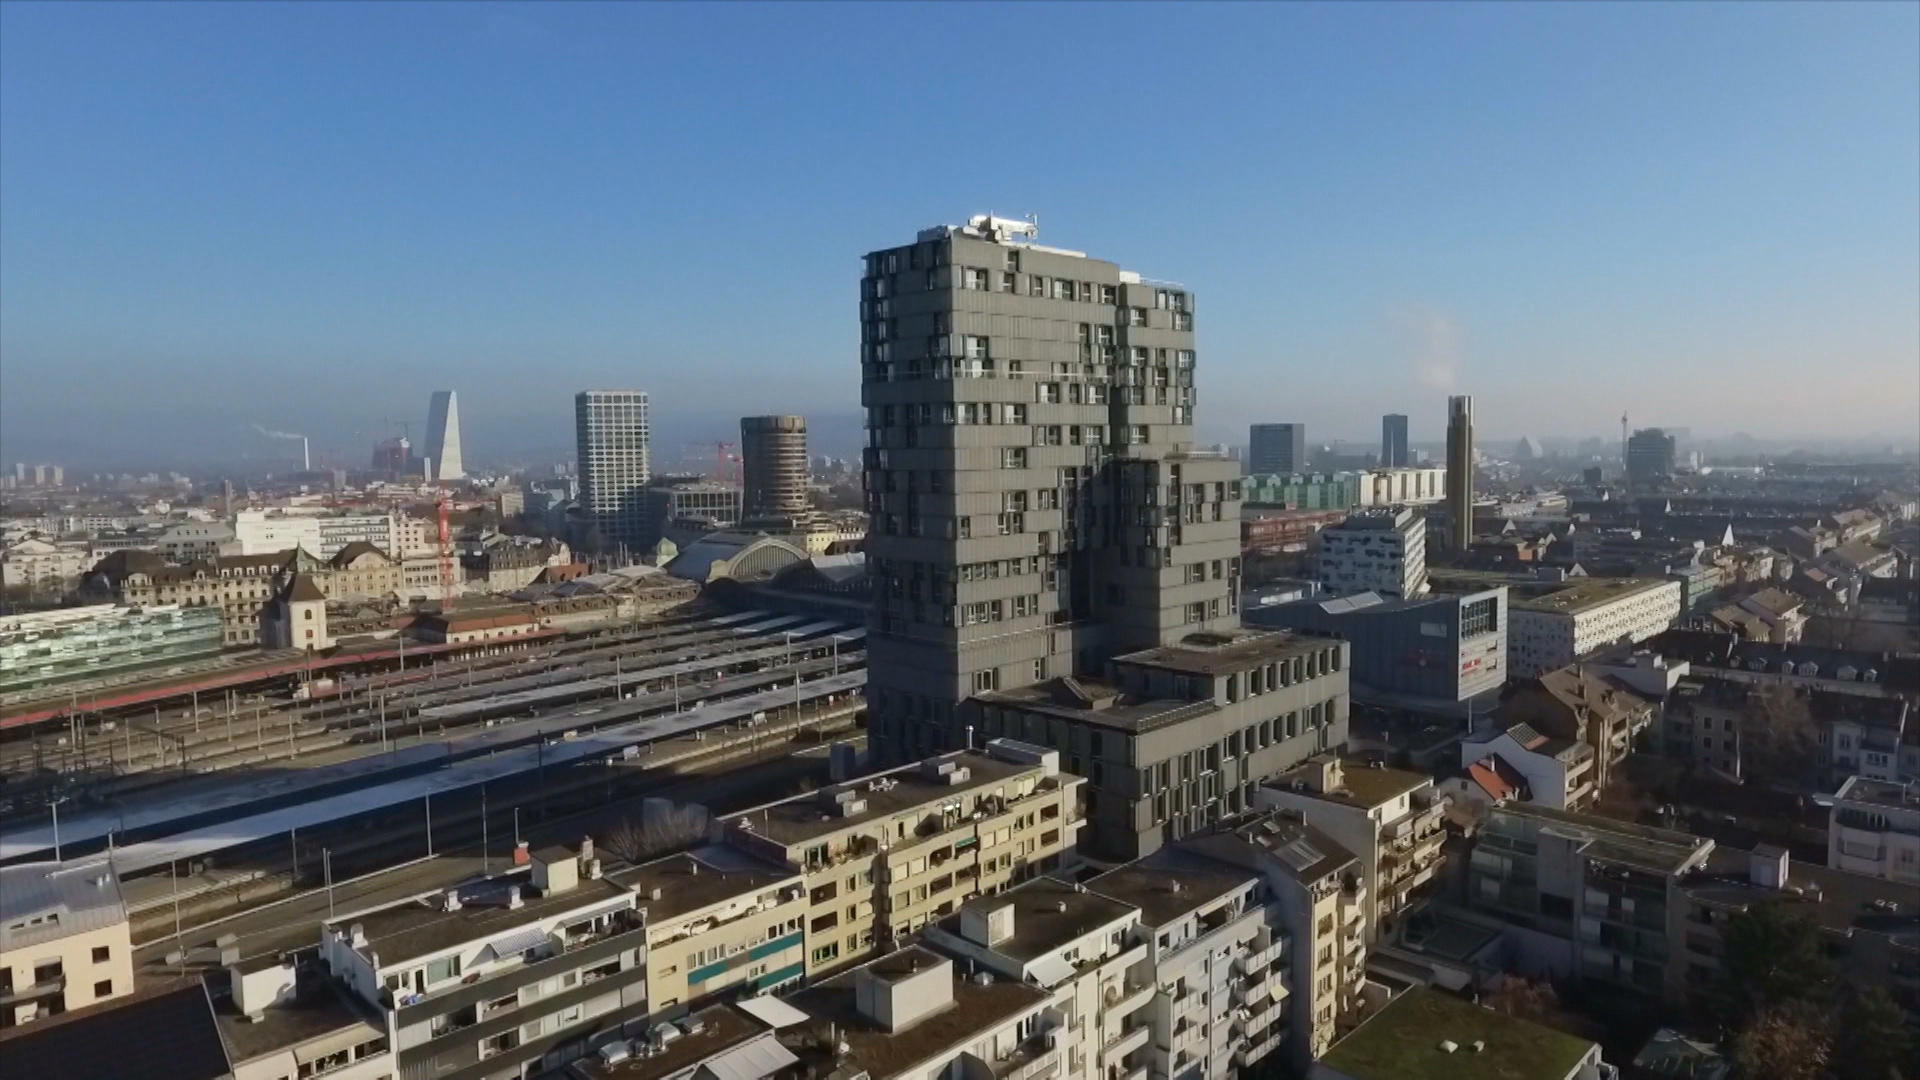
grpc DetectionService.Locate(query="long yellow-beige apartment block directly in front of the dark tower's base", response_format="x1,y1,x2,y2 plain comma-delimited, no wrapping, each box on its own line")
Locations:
724,740,1083,976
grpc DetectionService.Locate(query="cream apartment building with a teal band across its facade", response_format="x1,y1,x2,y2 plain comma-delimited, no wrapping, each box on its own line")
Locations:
609,844,808,1020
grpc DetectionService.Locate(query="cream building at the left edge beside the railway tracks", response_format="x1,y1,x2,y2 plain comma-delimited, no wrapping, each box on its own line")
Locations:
0,859,132,1022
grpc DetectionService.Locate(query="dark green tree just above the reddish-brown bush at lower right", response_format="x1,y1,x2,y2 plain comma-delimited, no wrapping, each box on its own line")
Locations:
1715,903,1834,1032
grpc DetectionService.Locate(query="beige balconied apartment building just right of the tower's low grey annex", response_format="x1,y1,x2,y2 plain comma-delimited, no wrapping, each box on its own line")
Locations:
1256,753,1448,942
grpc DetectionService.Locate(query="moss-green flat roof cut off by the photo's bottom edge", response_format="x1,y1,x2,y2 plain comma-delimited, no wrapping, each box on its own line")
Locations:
1321,986,1594,1080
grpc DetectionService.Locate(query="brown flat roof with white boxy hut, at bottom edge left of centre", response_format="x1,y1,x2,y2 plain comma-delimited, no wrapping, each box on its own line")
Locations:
787,947,1048,1080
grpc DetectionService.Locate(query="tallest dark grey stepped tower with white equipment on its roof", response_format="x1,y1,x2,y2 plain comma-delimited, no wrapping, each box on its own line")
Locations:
860,215,1240,759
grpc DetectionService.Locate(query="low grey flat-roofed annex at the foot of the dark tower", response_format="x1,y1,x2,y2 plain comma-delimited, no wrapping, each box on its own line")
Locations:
977,630,1350,859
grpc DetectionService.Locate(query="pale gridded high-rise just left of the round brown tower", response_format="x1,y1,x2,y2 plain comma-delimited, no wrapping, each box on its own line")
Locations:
574,390,651,557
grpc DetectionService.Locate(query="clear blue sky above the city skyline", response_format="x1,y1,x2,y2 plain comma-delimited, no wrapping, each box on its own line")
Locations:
0,2,1920,459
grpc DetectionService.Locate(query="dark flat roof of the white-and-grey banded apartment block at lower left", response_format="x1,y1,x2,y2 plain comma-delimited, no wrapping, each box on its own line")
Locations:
328,874,630,967
